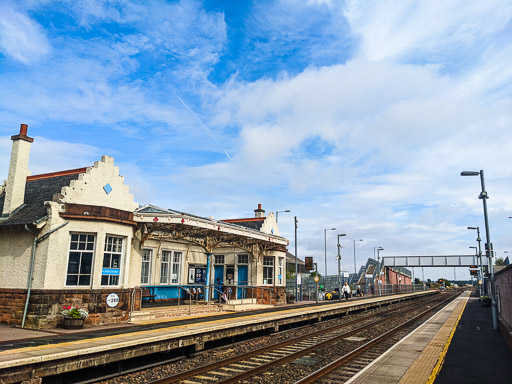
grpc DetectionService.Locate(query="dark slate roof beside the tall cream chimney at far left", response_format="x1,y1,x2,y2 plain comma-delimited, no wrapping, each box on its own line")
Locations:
0,173,80,226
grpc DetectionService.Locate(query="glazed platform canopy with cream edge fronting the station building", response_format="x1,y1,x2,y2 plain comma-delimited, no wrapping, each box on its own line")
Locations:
133,205,289,253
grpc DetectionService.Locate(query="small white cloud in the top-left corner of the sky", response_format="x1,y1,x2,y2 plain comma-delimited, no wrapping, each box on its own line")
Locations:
0,3,51,64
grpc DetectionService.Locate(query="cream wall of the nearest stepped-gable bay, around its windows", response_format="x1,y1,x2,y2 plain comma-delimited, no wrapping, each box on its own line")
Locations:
19,156,141,289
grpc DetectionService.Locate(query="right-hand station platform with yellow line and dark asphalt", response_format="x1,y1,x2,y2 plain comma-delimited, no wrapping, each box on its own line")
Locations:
347,291,512,384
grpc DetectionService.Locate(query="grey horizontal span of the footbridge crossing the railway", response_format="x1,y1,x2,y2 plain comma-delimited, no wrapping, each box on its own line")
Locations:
382,255,476,267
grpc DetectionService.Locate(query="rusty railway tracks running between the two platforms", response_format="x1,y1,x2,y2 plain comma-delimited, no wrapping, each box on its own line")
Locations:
142,295,457,384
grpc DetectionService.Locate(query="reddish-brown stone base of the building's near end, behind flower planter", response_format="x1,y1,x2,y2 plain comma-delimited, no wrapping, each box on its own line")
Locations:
0,289,140,329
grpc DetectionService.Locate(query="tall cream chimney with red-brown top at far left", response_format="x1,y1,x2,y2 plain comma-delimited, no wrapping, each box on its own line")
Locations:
2,124,34,216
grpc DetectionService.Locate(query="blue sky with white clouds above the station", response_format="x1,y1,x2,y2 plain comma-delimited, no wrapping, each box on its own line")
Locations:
0,0,512,279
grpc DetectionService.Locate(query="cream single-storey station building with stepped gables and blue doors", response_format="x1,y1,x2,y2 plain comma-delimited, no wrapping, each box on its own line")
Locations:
0,124,288,328
